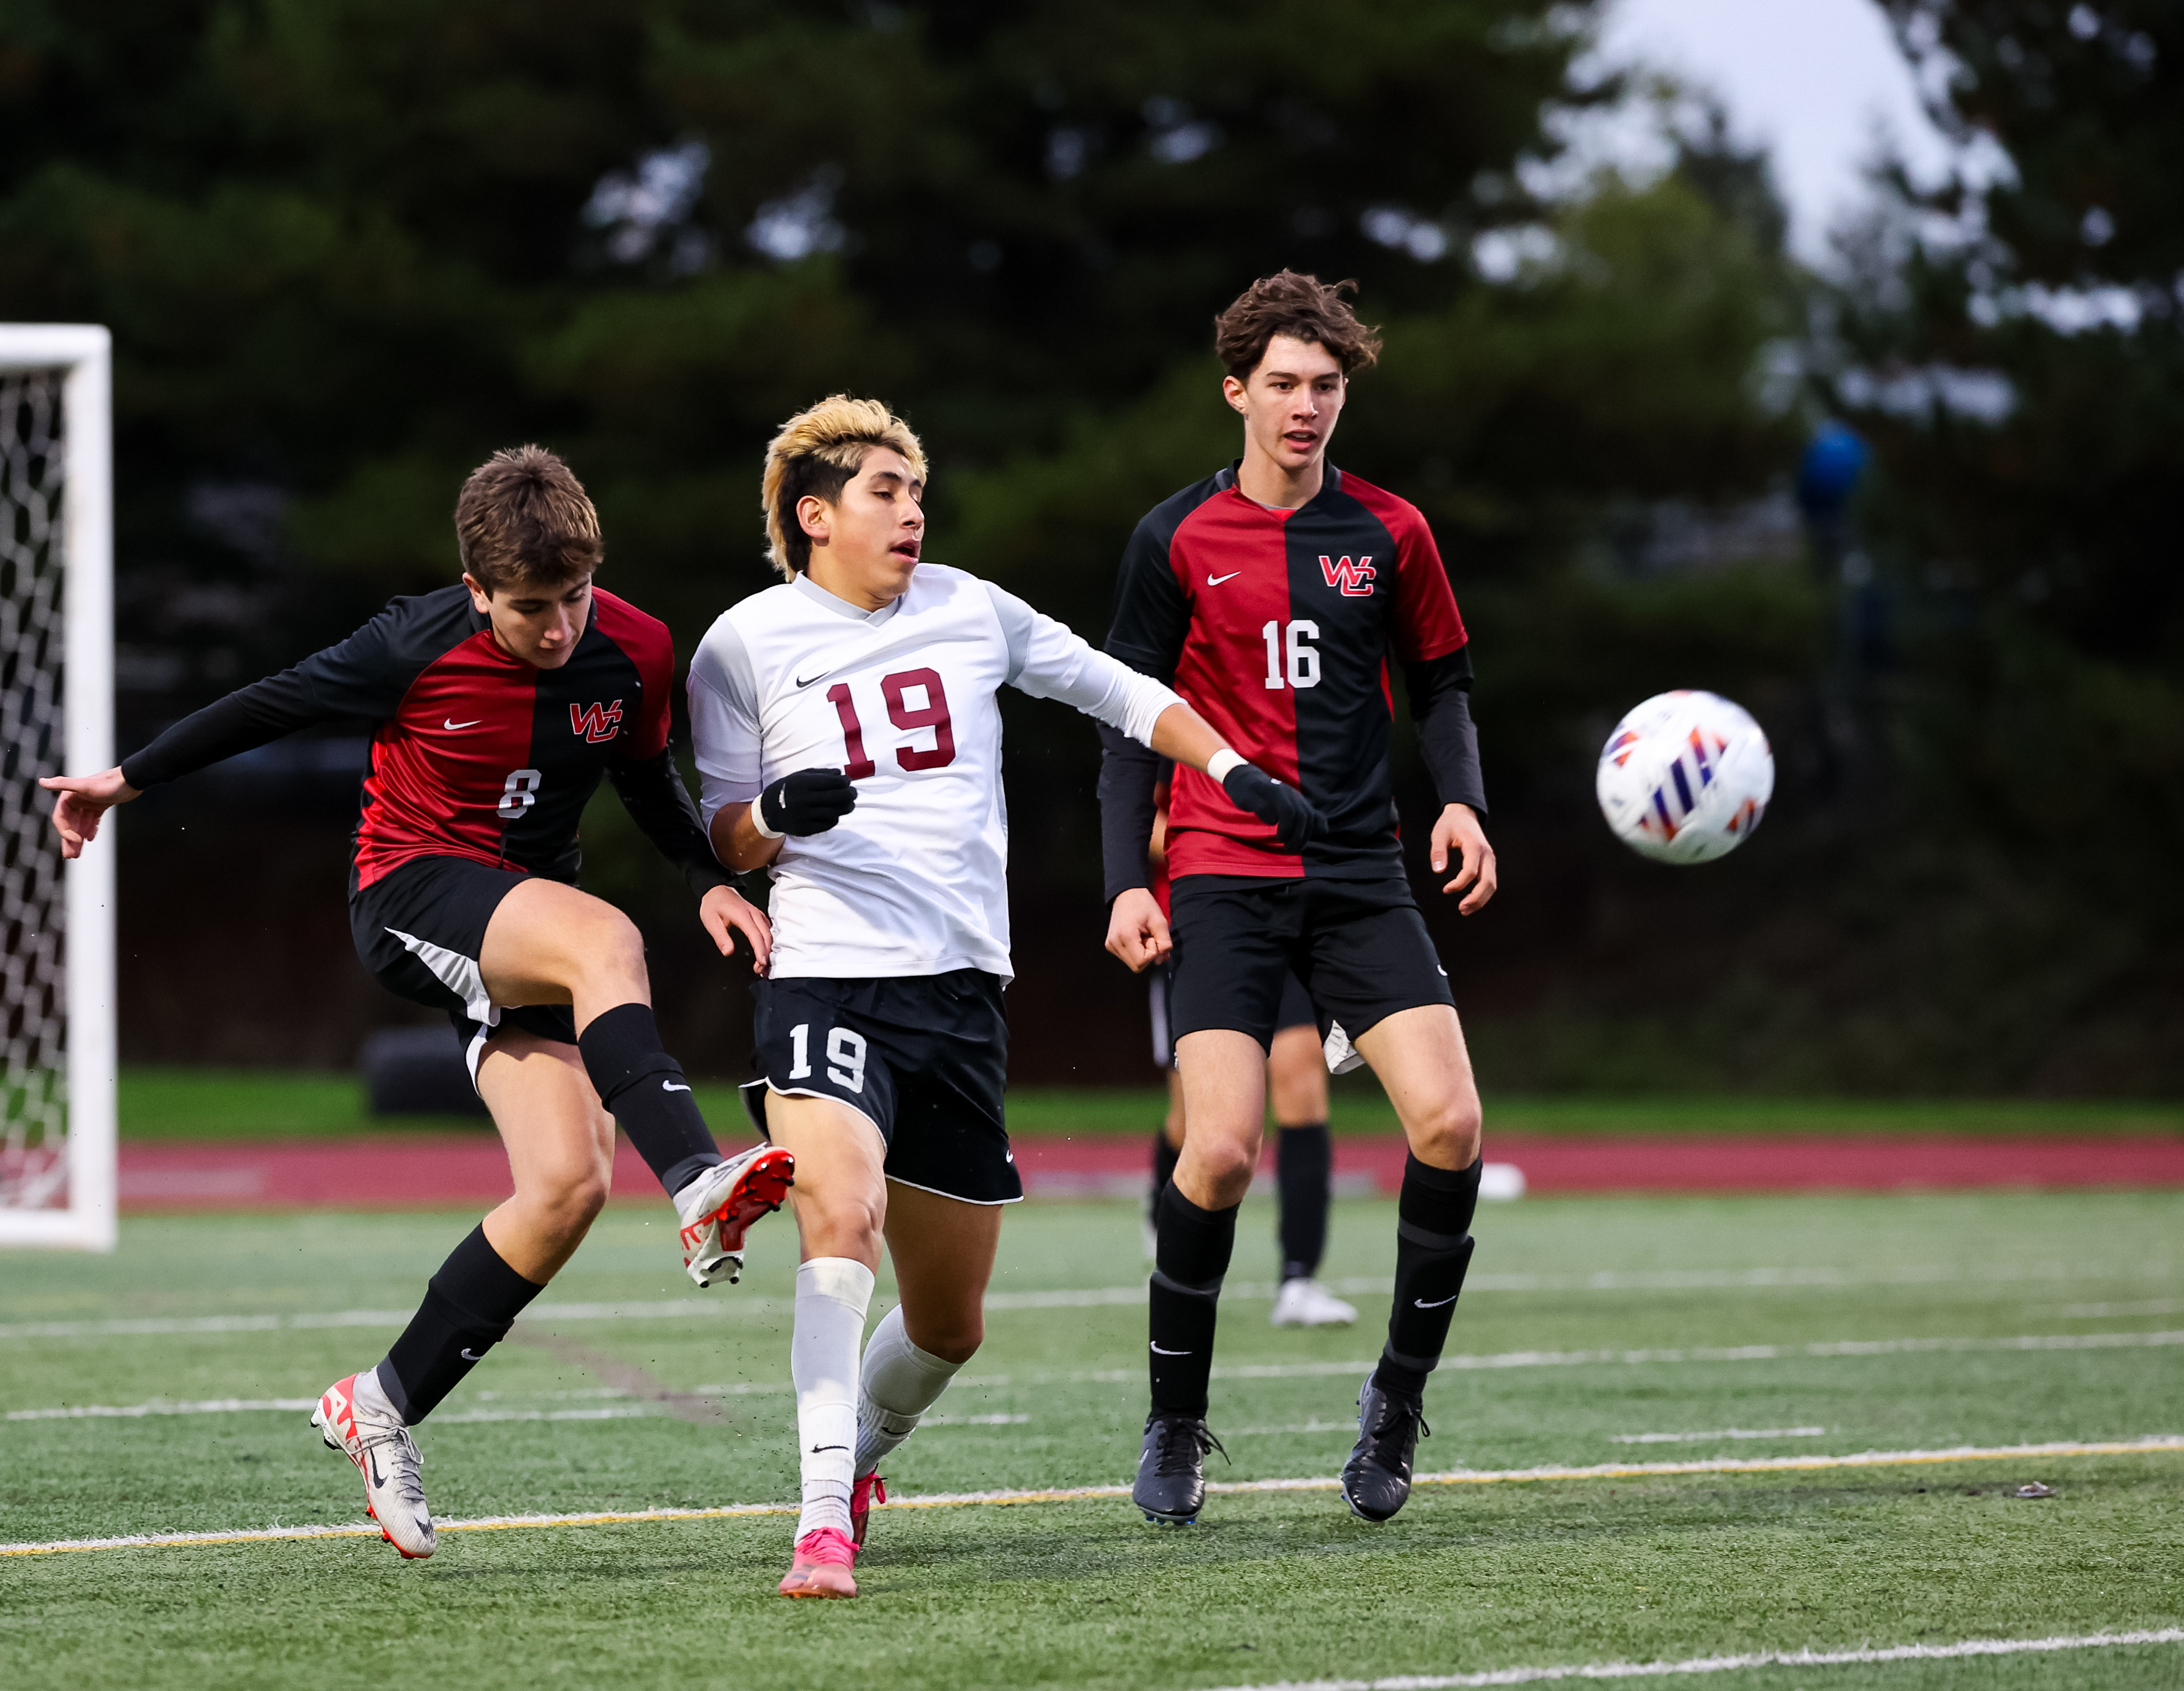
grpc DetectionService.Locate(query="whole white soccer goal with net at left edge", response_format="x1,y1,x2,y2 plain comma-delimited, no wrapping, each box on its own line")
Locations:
0,323,116,1250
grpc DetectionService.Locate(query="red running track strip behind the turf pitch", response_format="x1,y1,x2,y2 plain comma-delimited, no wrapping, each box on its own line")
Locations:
106,1134,2184,1211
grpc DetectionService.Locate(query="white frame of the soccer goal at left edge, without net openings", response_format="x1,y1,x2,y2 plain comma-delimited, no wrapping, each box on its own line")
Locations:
0,323,116,1250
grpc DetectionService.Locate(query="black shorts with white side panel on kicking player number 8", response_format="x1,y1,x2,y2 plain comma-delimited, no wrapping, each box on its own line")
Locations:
350,856,576,1084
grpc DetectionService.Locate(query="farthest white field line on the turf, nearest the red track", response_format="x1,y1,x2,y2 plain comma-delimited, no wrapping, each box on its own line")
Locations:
0,1261,2184,1341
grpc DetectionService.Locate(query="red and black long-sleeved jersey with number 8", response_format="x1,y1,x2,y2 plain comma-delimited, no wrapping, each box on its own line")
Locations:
122,585,727,891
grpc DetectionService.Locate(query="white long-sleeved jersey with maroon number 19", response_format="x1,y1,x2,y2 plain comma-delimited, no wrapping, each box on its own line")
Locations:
690,563,1177,981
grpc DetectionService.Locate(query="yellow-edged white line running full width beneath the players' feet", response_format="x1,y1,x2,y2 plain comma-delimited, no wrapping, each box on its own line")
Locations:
0,1433,2184,1573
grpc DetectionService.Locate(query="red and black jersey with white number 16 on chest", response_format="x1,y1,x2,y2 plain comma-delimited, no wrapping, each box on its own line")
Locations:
1107,465,1467,893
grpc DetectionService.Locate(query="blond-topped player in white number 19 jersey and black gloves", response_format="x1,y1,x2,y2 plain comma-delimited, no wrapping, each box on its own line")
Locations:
690,396,1325,1597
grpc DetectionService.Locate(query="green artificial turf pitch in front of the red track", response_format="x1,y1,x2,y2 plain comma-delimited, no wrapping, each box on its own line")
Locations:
0,1193,2184,1691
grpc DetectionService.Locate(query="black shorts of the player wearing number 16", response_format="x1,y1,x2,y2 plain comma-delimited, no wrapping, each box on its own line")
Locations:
1168,874,1457,1055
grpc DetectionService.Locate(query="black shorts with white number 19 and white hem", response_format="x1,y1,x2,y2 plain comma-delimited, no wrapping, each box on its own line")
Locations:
745,968,1024,1204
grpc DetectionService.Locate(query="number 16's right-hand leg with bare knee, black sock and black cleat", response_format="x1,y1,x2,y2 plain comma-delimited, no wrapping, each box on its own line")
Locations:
1343,1005,1481,1520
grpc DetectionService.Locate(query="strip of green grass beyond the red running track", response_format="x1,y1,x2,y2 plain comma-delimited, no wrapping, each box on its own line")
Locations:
120,1064,2184,1140
